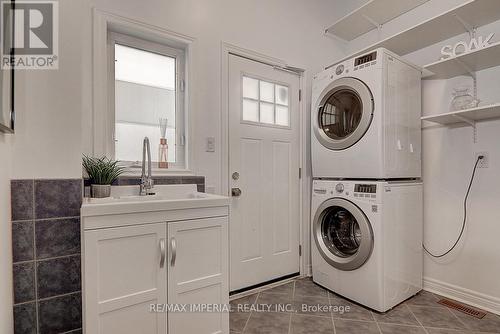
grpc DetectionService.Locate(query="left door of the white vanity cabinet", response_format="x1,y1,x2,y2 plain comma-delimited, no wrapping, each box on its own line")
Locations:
84,223,167,334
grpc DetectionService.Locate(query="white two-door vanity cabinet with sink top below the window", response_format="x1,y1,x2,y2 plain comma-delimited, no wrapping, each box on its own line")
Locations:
82,185,229,334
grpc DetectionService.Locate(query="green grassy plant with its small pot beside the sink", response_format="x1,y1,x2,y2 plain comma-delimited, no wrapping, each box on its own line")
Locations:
83,155,125,198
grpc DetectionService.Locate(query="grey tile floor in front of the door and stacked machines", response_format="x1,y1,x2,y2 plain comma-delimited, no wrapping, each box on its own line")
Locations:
229,278,500,334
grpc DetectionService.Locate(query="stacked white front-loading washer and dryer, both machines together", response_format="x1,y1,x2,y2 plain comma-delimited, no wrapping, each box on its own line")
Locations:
311,48,423,312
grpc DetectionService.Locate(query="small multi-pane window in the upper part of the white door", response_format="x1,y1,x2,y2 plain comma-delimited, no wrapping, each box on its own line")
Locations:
242,76,290,127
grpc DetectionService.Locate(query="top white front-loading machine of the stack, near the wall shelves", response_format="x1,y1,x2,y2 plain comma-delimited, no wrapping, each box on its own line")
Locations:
311,48,421,179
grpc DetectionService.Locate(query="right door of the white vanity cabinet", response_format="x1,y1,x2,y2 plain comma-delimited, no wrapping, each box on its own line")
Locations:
168,217,229,334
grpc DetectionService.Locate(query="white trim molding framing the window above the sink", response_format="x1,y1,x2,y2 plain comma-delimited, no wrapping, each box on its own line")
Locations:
91,8,196,174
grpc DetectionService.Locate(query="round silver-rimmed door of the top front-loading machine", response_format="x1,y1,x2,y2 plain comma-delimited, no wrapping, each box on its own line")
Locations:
312,77,373,150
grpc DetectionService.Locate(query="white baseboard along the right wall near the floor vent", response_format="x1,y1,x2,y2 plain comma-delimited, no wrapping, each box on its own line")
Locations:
424,277,500,315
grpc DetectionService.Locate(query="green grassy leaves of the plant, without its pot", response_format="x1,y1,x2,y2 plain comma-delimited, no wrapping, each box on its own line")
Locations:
82,155,125,185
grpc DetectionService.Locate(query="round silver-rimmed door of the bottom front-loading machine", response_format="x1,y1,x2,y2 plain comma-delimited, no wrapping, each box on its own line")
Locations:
313,198,373,271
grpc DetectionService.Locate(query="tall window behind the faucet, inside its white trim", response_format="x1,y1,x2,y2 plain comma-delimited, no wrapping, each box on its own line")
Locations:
109,33,186,170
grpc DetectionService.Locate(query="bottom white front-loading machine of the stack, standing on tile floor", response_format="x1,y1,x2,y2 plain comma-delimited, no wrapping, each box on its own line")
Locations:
311,180,423,312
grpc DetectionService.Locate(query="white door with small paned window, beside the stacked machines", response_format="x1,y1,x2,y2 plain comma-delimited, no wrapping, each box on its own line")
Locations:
228,55,300,291
